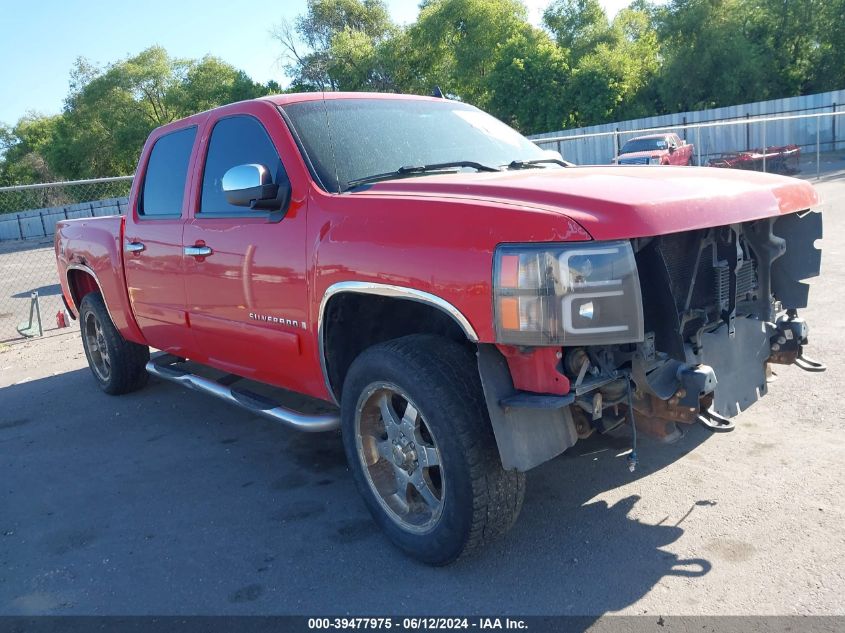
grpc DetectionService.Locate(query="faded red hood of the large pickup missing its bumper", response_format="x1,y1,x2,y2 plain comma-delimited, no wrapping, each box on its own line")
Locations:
347,165,819,240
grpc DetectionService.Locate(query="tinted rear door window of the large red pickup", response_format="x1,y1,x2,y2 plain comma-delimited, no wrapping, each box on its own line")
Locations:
138,127,197,217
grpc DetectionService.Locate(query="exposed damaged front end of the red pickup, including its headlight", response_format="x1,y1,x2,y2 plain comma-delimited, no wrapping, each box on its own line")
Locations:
479,211,824,470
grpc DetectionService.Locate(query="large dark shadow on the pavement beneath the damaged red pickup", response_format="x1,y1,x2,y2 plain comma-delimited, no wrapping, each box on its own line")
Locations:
0,369,711,615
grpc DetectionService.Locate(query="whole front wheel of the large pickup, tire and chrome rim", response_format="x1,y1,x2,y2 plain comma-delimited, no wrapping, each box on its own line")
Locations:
341,335,525,565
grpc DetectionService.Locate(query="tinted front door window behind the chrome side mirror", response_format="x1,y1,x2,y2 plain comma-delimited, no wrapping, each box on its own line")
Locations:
200,116,288,215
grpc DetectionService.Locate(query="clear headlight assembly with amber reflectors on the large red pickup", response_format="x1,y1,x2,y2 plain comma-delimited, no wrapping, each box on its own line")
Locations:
493,241,643,346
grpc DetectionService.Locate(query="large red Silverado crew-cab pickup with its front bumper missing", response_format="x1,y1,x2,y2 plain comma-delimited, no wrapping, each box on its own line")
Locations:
56,93,822,564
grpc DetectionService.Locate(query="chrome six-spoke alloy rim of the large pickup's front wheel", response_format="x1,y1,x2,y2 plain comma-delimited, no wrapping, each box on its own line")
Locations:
355,383,446,533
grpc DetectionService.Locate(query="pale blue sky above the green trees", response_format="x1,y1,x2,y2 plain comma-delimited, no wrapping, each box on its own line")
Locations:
0,0,630,124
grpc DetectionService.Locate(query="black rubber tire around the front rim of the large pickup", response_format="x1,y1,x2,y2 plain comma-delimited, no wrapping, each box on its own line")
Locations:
341,335,525,565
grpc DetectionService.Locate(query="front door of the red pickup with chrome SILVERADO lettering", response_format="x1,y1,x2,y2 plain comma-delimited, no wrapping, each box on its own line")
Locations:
183,115,307,385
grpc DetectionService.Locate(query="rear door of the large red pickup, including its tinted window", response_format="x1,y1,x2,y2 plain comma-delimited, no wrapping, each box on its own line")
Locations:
123,126,197,355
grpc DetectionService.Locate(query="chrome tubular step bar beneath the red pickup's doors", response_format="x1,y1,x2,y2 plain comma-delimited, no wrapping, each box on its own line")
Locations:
147,354,340,433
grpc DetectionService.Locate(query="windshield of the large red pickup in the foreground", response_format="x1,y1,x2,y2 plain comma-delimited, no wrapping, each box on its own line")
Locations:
282,98,548,192
